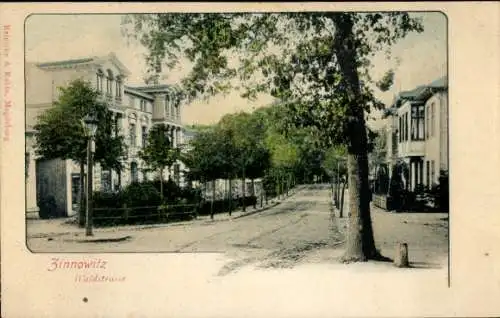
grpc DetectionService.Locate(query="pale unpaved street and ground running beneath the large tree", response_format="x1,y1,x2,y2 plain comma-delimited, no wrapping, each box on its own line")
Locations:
27,185,448,275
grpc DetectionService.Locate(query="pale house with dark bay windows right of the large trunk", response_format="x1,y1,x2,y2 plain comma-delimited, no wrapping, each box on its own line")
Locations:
384,77,449,191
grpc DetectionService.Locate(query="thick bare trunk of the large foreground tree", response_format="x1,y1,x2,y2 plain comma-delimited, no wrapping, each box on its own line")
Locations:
332,13,379,262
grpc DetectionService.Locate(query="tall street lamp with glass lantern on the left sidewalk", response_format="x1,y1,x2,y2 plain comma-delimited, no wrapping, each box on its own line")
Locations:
83,114,98,236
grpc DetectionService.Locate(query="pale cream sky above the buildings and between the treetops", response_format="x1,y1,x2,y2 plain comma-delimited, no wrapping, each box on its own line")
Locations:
25,13,447,125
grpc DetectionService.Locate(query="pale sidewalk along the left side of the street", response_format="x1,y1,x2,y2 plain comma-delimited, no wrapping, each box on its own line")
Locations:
26,190,297,241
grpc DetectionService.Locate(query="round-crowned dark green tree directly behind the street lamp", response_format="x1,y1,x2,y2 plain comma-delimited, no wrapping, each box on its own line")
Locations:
34,79,127,226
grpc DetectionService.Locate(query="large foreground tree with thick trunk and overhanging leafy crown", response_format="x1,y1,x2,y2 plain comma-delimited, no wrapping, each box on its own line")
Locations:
125,12,423,262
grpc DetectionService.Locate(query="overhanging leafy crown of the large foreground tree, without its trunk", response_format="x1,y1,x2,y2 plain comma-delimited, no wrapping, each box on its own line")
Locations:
124,12,422,143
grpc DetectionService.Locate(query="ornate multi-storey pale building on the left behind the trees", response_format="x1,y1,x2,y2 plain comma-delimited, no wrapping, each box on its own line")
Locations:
25,53,185,216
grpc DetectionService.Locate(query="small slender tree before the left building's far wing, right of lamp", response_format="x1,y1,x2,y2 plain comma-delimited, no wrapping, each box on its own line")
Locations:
139,124,180,200
